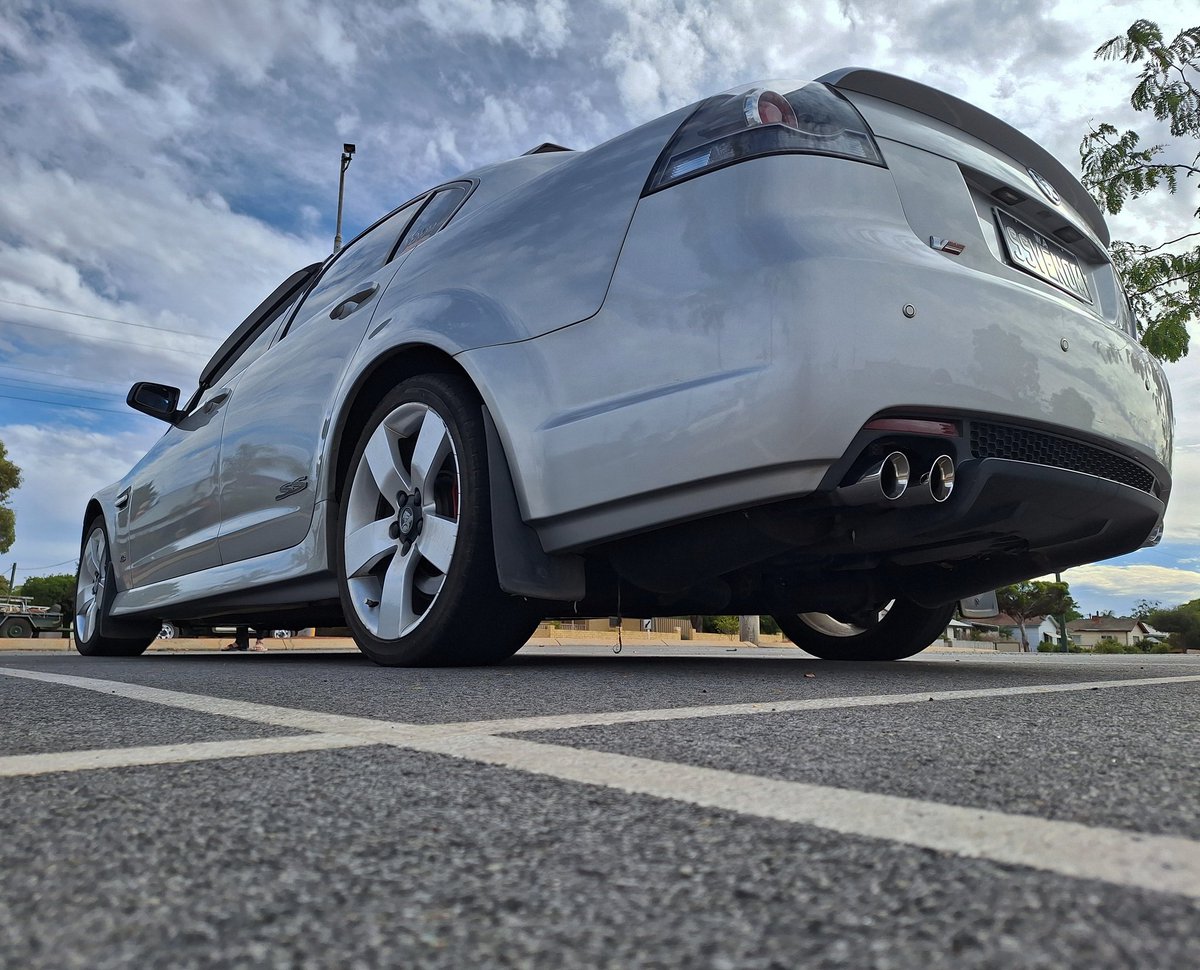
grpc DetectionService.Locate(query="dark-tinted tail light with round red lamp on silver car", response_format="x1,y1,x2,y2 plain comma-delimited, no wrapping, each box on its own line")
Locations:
646,82,883,193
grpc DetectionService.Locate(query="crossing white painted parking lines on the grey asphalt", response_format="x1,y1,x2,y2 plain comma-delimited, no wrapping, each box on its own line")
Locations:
0,667,1200,899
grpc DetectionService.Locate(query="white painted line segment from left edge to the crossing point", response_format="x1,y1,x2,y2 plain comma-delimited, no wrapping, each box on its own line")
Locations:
0,735,373,778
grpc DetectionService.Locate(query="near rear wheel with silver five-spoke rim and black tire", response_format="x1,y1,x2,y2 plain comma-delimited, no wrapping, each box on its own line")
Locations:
335,373,539,666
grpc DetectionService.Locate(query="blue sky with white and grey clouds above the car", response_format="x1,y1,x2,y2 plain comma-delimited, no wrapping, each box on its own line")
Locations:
0,0,1200,613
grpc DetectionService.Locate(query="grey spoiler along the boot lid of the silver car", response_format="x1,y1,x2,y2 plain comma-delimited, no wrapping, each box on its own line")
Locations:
817,67,1110,246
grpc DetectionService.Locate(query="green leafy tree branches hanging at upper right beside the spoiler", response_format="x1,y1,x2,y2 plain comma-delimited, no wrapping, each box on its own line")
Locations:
1079,20,1200,360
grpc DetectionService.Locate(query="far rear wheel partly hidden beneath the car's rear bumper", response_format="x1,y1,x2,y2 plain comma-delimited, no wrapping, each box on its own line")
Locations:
775,598,954,660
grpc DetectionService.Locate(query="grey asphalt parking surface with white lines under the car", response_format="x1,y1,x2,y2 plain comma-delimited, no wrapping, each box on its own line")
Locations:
0,647,1200,970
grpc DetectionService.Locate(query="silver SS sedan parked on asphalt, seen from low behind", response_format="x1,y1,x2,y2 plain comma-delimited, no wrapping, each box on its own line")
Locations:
76,68,1172,665
